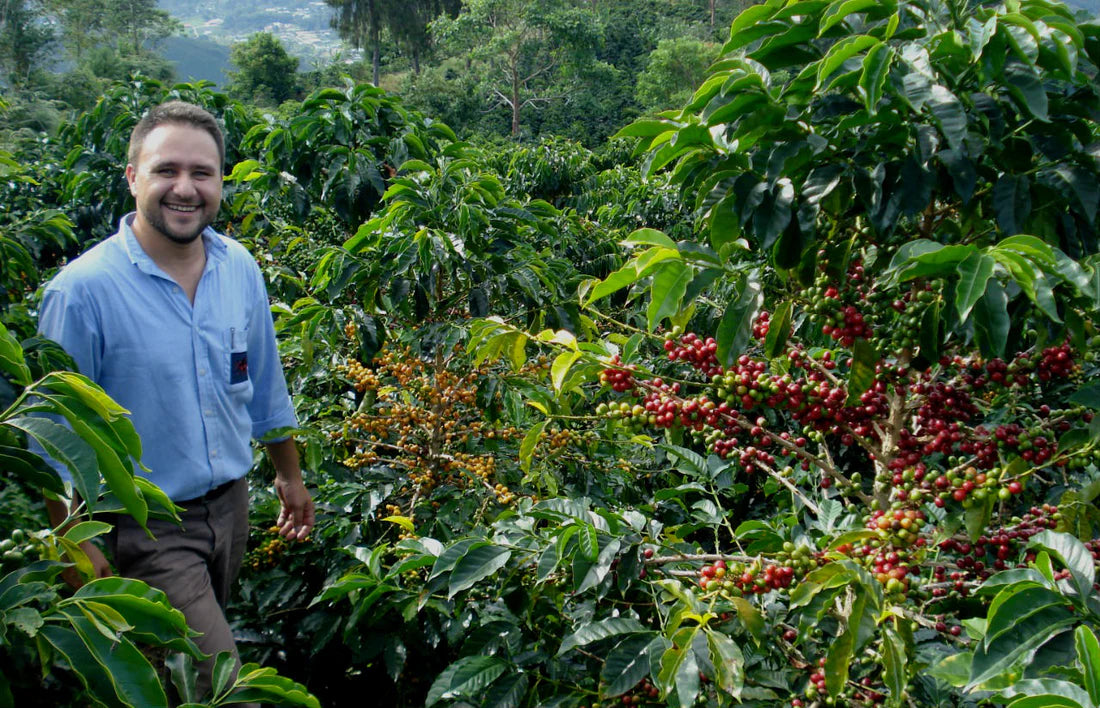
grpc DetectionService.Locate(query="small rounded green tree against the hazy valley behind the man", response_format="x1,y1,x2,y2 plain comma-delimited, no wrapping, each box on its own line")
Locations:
227,32,298,107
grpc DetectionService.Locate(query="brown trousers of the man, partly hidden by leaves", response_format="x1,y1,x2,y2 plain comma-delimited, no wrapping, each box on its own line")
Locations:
107,478,249,696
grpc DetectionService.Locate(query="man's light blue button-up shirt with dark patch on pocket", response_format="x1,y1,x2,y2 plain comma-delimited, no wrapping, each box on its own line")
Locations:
39,214,297,501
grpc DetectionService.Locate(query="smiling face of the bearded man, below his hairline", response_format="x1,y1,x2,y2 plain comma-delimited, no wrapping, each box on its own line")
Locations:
127,123,221,244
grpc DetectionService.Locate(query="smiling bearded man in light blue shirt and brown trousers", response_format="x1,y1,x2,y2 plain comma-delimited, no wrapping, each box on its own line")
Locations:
40,101,314,703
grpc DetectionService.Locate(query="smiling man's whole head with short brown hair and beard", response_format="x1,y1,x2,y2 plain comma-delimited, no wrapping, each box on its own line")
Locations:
127,101,226,250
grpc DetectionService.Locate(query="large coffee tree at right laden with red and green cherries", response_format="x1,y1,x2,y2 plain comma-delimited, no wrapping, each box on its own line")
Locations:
444,2,1100,706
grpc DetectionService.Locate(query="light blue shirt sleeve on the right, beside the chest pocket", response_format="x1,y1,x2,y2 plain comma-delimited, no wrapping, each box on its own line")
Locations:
249,264,298,439
